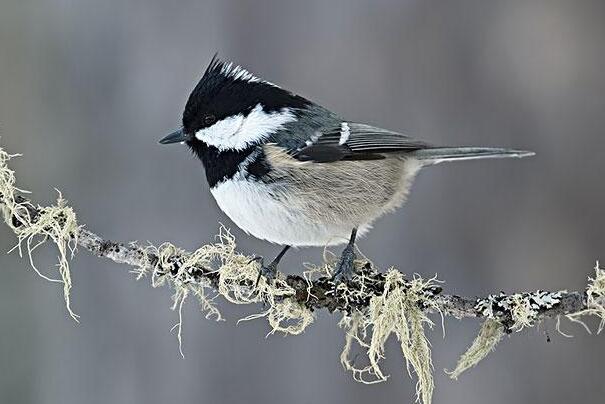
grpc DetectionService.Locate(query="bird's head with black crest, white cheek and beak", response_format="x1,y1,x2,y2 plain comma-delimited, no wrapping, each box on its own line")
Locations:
160,56,310,151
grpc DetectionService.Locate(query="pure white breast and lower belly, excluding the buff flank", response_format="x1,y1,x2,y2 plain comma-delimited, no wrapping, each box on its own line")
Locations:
211,180,369,246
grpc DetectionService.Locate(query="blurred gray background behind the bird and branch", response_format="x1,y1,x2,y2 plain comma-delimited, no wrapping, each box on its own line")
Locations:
0,0,605,404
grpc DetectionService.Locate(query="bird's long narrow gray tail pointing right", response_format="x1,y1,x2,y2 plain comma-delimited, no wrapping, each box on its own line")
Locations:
411,147,536,164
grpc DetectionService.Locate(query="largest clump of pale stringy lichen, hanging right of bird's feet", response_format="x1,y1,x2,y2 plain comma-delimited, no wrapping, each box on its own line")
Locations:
339,269,437,404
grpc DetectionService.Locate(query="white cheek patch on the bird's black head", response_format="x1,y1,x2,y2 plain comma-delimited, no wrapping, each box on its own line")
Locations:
195,104,296,150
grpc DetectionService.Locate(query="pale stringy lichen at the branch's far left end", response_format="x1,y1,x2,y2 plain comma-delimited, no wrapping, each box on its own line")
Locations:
0,147,79,321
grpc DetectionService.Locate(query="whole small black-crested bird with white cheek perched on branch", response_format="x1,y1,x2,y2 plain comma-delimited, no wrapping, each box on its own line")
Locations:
160,56,534,282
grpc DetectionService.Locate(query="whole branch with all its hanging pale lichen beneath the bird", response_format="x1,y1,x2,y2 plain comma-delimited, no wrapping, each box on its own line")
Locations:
0,143,605,403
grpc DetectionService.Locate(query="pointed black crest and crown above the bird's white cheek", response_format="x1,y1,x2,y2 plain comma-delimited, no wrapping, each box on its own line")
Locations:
183,55,310,133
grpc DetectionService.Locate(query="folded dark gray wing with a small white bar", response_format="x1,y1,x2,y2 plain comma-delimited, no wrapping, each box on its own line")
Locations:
292,122,433,163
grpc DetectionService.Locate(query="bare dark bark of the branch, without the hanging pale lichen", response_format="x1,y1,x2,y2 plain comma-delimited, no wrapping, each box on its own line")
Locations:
5,195,605,333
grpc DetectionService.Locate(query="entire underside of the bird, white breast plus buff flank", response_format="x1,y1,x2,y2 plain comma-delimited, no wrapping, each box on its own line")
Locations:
211,153,421,246
